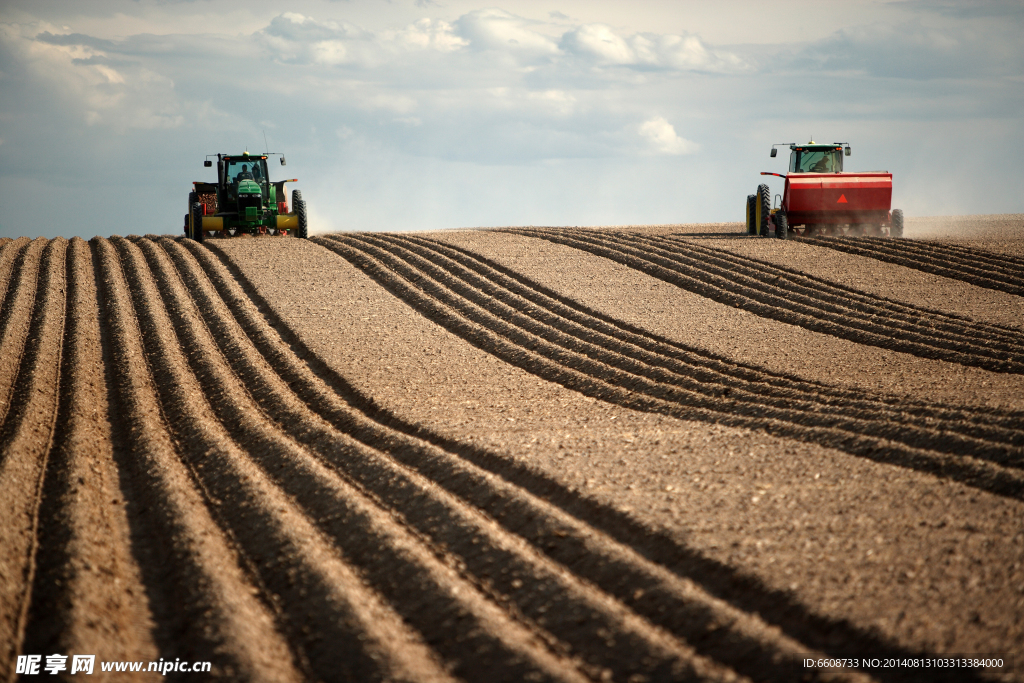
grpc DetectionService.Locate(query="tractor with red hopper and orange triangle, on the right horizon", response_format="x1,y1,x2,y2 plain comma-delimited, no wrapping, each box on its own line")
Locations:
746,140,903,240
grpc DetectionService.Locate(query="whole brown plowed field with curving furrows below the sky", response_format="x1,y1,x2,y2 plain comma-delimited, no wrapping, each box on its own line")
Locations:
0,216,1024,683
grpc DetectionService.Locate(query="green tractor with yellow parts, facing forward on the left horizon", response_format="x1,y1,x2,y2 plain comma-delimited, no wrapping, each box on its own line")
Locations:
185,152,309,242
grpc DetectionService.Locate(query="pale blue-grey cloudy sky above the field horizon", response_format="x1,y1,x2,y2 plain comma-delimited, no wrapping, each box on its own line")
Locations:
0,0,1024,238
